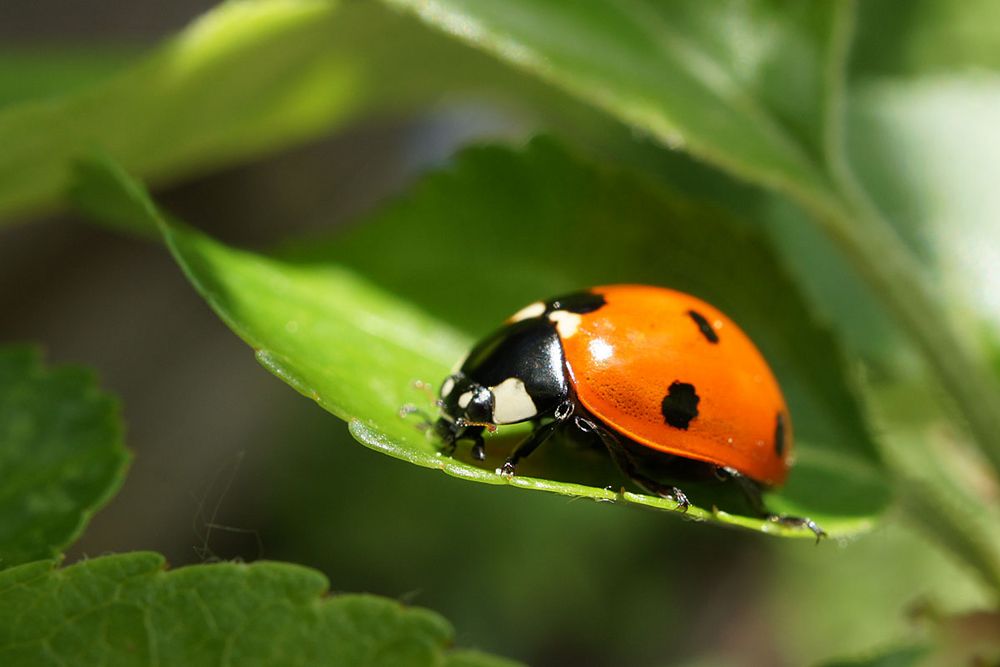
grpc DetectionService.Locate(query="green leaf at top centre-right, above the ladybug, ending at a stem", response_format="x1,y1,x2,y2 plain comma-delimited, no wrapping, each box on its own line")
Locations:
378,0,853,208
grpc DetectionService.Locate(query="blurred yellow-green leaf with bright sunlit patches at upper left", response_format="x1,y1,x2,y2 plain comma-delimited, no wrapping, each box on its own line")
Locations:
0,0,616,227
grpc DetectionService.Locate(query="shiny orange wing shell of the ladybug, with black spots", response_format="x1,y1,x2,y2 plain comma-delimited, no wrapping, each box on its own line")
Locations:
562,285,792,485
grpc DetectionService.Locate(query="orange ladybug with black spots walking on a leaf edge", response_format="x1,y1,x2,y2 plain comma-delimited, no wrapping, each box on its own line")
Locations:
422,285,825,539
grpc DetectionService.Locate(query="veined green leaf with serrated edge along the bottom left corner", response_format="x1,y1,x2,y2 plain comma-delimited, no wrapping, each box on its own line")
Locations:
0,553,513,667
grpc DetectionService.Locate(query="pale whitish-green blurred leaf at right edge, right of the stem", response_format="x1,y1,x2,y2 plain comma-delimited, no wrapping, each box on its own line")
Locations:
849,75,1000,366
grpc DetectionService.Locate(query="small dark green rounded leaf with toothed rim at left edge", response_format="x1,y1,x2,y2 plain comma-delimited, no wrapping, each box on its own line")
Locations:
0,346,129,567
